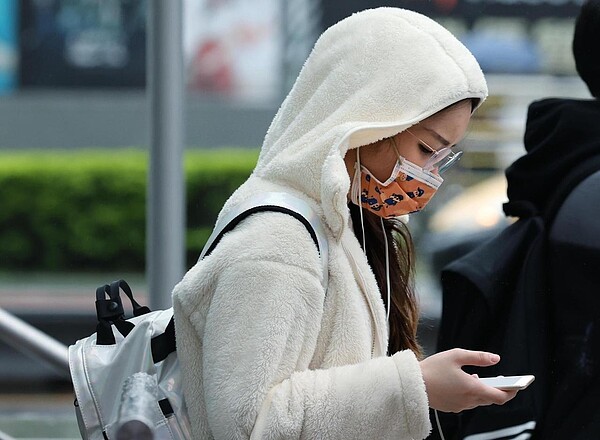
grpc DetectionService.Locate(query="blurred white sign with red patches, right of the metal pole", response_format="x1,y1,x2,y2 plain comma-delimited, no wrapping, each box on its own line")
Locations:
184,0,281,100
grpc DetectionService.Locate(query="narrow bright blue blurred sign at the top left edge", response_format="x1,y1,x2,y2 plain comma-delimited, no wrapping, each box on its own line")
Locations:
0,0,18,95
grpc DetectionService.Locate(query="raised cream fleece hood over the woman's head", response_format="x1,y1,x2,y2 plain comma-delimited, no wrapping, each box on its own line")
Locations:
225,8,487,238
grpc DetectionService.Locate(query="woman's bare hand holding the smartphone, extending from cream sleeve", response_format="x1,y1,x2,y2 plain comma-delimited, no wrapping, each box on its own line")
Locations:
420,348,517,412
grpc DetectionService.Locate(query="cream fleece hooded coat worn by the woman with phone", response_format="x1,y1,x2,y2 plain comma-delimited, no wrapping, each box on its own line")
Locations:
173,8,487,440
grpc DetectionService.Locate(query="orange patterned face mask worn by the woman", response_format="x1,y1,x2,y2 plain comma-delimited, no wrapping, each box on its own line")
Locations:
350,158,444,218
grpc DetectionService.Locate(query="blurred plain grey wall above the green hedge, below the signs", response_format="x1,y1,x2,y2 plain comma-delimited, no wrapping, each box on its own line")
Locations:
0,90,279,148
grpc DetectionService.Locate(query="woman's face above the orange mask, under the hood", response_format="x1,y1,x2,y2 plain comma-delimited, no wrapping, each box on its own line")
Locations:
344,100,471,182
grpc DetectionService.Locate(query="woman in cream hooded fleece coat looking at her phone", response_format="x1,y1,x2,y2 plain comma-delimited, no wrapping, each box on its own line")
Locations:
173,8,514,439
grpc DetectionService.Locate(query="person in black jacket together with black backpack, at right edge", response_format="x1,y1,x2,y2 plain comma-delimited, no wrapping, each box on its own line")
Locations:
437,0,600,440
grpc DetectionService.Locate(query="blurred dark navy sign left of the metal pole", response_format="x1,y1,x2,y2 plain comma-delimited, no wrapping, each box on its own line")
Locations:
20,0,146,87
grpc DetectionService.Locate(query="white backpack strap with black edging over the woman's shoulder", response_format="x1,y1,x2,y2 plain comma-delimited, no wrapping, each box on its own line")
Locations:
199,192,329,291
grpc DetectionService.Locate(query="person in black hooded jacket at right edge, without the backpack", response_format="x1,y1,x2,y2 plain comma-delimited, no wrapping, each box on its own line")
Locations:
506,0,600,439
